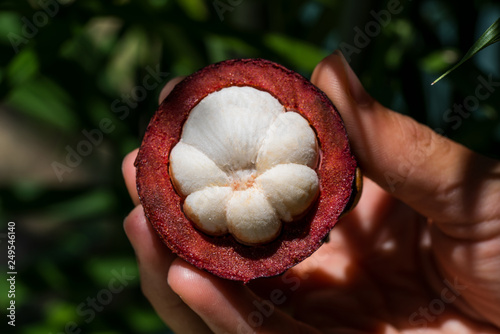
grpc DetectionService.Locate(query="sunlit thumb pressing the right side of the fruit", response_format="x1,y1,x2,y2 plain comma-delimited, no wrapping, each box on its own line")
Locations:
311,52,500,227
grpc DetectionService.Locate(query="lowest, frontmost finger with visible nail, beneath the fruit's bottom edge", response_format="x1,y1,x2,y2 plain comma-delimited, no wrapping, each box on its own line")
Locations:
168,259,318,334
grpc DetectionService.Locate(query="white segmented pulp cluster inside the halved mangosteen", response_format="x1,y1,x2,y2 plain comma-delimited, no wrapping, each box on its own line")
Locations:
170,87,319,245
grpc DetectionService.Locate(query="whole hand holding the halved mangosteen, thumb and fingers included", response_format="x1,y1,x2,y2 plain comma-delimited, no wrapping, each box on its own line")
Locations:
123,52,500,334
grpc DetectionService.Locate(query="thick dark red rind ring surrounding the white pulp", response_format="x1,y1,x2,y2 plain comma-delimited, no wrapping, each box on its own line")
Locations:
135,59,360,282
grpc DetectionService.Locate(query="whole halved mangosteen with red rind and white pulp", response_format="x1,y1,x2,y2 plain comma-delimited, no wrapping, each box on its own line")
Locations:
135,59,361,282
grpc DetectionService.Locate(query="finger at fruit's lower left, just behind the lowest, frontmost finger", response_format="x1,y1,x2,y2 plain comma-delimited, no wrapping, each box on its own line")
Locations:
124,205,211,333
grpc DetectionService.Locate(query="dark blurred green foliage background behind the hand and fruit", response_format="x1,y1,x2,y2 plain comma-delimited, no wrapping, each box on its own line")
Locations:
0,0,500,333
